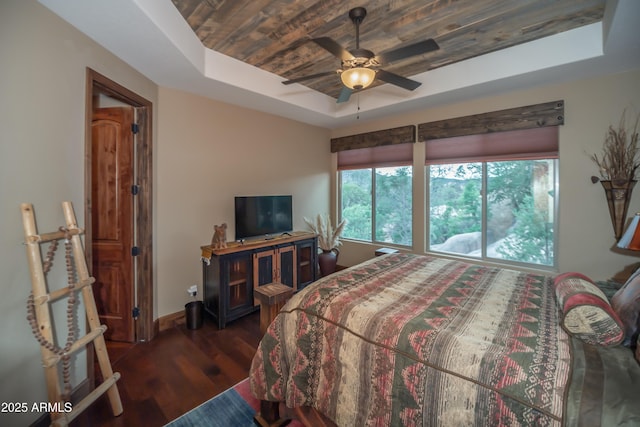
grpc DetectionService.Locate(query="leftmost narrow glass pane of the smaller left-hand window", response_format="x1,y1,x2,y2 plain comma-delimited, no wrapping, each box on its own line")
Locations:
340,169,373,241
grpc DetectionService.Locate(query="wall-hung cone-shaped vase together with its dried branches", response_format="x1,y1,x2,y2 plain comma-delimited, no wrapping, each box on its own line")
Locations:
591,109,640,240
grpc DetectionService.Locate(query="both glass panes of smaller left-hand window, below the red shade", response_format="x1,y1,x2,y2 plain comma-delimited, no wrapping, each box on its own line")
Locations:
340,166,413,246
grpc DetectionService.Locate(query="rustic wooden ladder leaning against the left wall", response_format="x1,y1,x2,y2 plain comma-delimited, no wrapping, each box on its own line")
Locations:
20,202,122,426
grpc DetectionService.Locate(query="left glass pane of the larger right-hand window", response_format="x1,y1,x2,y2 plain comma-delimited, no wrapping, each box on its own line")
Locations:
428,163,482,257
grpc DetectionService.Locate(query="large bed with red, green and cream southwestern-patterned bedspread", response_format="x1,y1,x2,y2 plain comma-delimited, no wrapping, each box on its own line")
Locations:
250,253,640,427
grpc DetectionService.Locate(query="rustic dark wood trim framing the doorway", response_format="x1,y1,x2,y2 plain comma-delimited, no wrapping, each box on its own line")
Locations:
84,68,154,341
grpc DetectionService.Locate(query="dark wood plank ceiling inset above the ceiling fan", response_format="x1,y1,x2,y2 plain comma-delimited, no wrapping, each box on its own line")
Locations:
172,0,606,98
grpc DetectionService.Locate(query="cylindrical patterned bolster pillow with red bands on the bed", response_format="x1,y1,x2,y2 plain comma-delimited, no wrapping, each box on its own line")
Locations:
554,273,624,346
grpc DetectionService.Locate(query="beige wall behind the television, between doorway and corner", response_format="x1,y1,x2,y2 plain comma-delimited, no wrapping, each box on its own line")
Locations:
154,88,331,316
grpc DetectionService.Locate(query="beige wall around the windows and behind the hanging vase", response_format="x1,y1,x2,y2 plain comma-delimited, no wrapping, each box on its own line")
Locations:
331,70,640,279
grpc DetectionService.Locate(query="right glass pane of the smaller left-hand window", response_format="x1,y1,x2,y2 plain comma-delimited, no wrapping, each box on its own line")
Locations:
375,166,413,246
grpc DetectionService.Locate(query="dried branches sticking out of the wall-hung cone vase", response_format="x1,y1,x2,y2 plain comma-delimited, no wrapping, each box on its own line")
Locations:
591,109,640,181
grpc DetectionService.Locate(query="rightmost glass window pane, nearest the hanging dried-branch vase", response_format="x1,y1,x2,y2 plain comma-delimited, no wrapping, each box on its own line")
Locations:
487,159,555,266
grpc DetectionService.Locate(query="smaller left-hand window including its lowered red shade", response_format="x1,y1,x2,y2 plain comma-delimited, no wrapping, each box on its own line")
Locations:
338,144,413,246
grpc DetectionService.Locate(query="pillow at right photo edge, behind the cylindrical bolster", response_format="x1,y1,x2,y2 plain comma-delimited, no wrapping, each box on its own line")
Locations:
611,270,640,347
